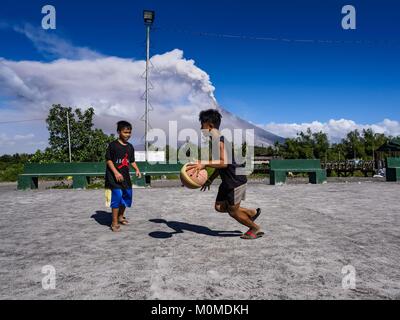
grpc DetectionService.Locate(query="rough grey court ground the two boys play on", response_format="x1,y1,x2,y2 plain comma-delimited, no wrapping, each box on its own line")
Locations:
0,181,400,299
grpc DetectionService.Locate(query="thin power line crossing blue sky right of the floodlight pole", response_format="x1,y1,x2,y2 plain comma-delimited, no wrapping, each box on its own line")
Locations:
154,27,400,45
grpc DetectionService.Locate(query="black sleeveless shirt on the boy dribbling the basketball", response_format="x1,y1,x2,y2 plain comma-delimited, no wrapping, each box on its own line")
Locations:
218,136,247,189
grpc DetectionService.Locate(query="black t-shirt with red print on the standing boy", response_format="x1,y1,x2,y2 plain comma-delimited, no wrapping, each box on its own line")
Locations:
105,140,135,189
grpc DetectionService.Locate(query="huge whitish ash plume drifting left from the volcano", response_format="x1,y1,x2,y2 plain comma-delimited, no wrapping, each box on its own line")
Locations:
0,25,217,152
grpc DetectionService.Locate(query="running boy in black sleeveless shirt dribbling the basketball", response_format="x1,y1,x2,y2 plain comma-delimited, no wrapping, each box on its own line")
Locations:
187,109,264,239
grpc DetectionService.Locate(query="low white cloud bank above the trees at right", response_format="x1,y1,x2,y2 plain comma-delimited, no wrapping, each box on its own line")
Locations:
260,119,400,141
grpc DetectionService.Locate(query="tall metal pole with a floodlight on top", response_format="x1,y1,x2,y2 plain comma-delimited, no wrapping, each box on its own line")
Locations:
143,10,155,161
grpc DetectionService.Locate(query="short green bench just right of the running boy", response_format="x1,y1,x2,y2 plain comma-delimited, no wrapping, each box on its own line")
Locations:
270,159,326,185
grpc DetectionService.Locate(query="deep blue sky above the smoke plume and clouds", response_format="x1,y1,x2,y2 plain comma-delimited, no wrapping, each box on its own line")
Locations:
0,0,400,154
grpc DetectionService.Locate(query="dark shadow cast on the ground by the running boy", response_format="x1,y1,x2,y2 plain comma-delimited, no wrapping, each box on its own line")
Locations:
149,219,242,239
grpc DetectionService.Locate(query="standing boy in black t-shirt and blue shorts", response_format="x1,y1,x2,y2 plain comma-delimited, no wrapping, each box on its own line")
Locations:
105,121,142,232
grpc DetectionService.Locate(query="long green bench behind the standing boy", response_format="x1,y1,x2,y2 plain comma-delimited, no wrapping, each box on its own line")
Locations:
18,162,182,190
